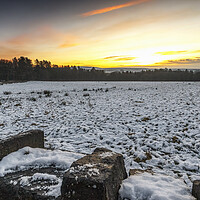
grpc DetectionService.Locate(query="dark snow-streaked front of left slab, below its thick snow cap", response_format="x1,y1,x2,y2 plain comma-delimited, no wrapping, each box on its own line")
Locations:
0,168,63,200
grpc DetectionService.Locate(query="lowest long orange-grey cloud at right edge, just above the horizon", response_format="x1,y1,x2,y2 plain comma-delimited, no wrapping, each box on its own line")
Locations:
156,57,200,65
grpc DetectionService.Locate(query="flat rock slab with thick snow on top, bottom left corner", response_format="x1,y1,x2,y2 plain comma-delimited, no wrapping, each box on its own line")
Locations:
0,147,84,200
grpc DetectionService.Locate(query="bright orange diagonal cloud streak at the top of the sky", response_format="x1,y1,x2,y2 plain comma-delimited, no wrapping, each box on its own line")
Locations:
82,0,150,17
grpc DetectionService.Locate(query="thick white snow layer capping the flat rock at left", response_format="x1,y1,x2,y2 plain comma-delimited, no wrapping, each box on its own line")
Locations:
0,147,84,176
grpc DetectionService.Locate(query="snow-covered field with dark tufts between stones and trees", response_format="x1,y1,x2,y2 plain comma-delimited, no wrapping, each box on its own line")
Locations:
0,82,200,188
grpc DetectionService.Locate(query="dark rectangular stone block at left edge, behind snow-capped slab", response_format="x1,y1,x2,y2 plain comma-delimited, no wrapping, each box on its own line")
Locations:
0,130,44,160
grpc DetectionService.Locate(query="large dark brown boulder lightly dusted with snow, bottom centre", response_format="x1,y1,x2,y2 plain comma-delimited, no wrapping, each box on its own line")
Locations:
61,148,127,200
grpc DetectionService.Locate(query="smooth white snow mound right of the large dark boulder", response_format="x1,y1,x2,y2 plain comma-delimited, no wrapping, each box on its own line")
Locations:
119,173,195,200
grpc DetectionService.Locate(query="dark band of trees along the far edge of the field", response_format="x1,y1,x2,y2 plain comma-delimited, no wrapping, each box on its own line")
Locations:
0,57,200,81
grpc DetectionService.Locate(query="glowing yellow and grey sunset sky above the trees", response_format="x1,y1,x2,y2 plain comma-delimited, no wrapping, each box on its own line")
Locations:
0,0,200,69
